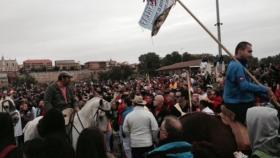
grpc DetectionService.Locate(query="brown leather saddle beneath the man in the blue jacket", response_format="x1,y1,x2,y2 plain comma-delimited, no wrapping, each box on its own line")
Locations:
219,105,251,151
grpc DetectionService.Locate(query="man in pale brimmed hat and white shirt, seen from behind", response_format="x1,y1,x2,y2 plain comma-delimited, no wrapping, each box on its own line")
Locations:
123,96,158,158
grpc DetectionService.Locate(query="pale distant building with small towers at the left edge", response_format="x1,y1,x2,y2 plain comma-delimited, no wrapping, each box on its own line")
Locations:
0,56,19,72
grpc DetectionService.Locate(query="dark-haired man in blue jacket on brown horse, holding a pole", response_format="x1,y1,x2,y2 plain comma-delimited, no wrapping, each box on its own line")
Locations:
223,42,273,123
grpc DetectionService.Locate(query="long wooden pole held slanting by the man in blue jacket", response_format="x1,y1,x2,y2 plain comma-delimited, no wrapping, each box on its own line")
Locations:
176,0,280,108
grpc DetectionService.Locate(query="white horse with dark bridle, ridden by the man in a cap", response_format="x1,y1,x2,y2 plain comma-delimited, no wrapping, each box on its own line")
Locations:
23,97,111,148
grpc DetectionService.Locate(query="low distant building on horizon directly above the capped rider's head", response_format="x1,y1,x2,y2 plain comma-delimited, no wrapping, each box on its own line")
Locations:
55,60,81,70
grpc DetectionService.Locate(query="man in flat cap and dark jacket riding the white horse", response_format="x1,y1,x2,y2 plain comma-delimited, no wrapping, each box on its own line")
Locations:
44,71,78,111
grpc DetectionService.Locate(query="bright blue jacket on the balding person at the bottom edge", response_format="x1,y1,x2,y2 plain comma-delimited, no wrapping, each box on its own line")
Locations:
147,141,193,158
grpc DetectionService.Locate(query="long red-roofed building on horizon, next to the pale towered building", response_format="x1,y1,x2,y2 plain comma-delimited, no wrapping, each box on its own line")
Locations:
23,59,52,71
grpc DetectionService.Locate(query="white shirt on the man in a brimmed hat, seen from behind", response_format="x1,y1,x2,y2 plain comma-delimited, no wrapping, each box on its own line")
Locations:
123,106,158,148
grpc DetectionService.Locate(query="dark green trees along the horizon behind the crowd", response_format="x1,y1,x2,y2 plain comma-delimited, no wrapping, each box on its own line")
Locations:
7,51,280,85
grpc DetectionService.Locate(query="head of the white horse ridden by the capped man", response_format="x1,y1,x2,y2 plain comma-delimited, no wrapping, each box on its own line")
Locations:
79,97,111,131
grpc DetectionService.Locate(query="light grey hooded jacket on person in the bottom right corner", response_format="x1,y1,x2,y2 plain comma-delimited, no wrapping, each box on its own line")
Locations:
246,107,280,158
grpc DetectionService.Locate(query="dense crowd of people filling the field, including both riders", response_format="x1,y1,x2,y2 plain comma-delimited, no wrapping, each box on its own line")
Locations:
0,43,280,158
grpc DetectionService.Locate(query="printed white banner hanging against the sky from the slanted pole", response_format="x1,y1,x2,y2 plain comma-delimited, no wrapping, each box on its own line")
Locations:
139,0,175,36
